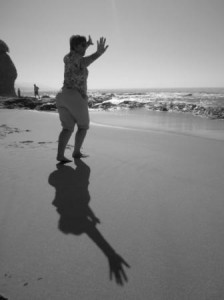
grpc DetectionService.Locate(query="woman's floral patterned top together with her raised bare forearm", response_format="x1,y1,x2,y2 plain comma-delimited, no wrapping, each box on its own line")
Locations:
63,50,99,99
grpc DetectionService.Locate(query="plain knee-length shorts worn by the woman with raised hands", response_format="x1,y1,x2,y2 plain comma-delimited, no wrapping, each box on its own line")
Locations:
56,89,89,131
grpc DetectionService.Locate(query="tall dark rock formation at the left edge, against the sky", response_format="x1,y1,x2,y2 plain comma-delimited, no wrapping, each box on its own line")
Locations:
0,40,17,97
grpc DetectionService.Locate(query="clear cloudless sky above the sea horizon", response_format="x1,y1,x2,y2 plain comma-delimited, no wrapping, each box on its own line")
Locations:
0,0,224,90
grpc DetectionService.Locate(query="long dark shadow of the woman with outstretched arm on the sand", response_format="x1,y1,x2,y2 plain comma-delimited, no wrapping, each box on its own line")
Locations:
48,159,130,285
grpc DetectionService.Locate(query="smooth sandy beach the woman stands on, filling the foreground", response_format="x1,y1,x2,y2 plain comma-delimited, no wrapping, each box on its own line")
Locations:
0,109,224,300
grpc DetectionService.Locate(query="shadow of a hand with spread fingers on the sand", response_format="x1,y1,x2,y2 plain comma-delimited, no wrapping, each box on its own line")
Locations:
108,253,130,285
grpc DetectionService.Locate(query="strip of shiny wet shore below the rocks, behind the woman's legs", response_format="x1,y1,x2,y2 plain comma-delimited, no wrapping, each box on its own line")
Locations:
0,108,224,141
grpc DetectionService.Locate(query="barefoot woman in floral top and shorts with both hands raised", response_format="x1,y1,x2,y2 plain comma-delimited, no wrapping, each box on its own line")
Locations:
56,35,108,163
